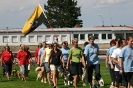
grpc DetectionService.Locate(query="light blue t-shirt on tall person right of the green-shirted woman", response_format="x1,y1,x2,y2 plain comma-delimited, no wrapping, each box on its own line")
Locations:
84,44,99,65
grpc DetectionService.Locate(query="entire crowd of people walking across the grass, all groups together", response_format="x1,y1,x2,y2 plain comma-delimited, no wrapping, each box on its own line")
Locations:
1,36,133,88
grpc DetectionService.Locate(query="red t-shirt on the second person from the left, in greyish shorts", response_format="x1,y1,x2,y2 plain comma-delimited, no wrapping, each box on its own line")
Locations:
17,50,30,65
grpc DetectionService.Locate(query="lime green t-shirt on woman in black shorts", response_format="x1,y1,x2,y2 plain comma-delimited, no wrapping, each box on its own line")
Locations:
68,47,83,63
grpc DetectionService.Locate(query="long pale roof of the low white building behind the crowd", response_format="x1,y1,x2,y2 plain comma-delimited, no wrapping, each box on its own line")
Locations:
0,26,133,33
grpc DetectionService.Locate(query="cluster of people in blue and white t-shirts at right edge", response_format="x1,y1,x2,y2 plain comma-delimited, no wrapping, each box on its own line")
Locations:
106,36,133,88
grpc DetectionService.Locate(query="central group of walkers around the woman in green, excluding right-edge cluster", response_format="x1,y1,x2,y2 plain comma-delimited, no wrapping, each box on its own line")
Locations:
34,36,101,88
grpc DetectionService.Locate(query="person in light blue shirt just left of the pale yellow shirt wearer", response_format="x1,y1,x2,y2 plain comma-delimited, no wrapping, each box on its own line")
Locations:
38,41,47,83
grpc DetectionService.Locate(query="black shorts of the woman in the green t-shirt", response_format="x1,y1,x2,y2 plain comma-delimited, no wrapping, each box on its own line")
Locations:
70,62,83,75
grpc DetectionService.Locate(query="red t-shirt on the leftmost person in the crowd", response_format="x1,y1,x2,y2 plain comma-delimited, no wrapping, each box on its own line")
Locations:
1,51,13,64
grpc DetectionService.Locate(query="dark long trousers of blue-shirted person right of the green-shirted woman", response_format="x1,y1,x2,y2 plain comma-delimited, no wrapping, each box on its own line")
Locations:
87,64,101,83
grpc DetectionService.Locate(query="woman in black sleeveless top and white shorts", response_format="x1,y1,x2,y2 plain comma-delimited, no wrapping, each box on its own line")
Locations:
48,43,62,88
